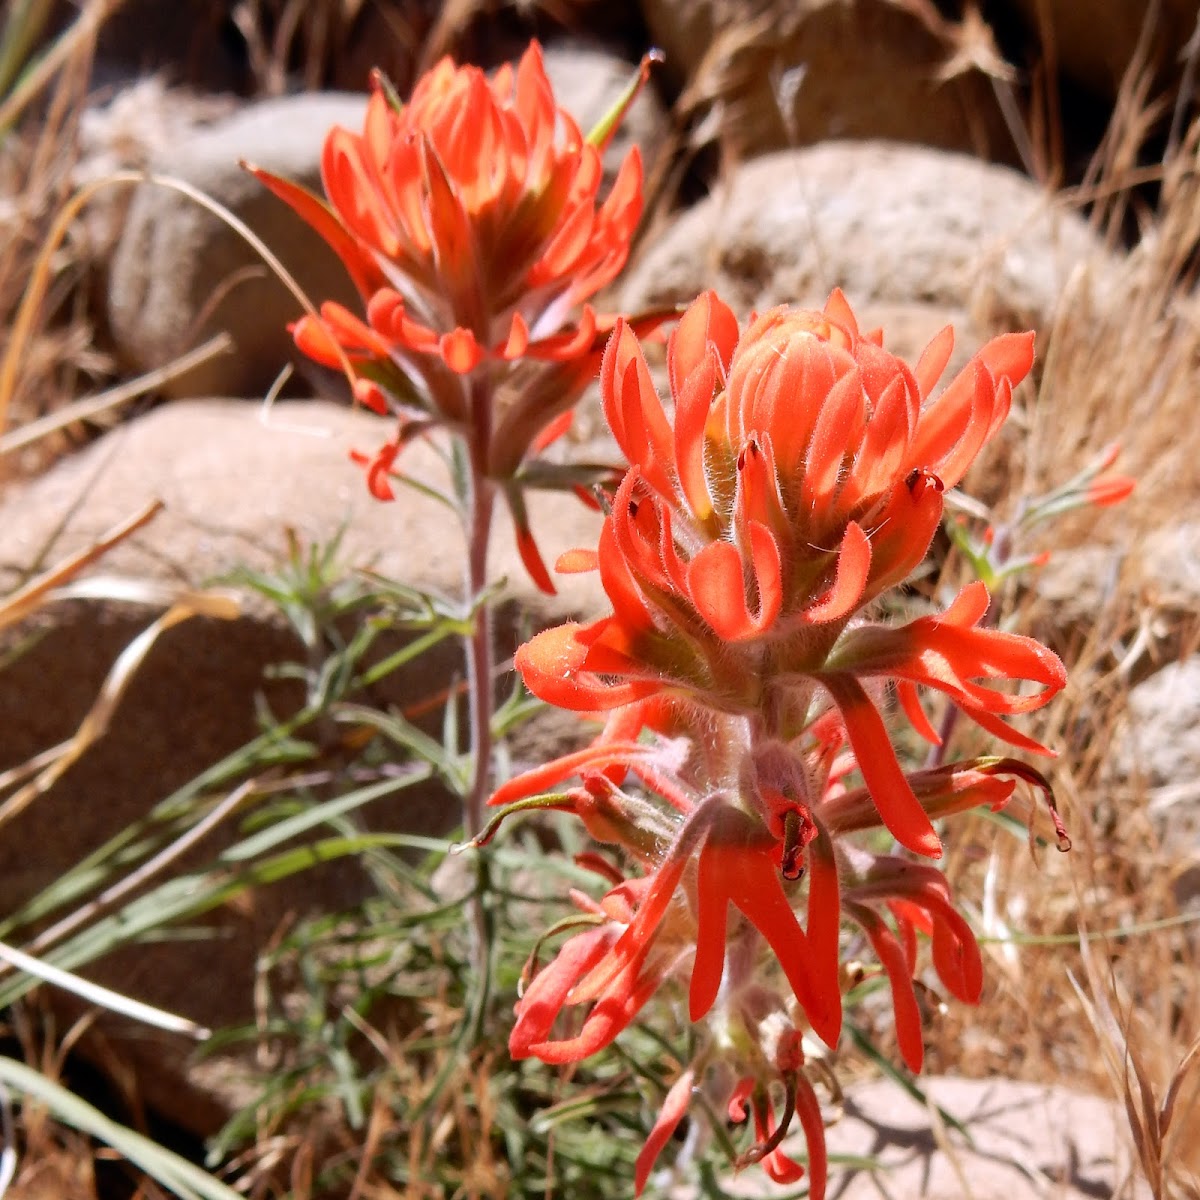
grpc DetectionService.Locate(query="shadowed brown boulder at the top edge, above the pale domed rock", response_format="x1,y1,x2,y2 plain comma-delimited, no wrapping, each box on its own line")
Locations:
643,0,1014,161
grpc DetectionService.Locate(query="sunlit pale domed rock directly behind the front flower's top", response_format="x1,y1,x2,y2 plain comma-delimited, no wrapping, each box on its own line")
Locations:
620,142,1111,328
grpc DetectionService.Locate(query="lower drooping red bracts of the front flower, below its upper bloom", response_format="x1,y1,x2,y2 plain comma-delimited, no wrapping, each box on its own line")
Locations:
485,700,1040,1195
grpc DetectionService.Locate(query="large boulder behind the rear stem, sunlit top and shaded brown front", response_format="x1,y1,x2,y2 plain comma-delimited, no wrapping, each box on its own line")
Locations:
0,401,601,1135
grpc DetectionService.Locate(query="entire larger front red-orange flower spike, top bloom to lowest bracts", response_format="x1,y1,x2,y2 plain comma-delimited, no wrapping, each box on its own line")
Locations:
492,293,1066,1195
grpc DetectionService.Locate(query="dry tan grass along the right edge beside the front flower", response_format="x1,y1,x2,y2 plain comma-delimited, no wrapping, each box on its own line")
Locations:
902,96,1200,1196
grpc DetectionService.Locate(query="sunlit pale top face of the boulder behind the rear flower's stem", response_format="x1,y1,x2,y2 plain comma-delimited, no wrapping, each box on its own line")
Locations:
0,400,600,616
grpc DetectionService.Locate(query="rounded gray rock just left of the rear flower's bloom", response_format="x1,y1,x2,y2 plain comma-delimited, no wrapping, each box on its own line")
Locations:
108,94,365,396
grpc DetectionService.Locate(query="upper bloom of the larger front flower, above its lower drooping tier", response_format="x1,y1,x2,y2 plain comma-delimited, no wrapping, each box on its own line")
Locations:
516,293,1066,854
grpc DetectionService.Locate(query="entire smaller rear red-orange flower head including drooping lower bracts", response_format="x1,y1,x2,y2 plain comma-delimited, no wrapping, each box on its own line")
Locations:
250,42,668,590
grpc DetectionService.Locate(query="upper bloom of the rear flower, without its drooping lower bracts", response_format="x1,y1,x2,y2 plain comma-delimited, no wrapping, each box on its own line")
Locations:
254,42,642,374
